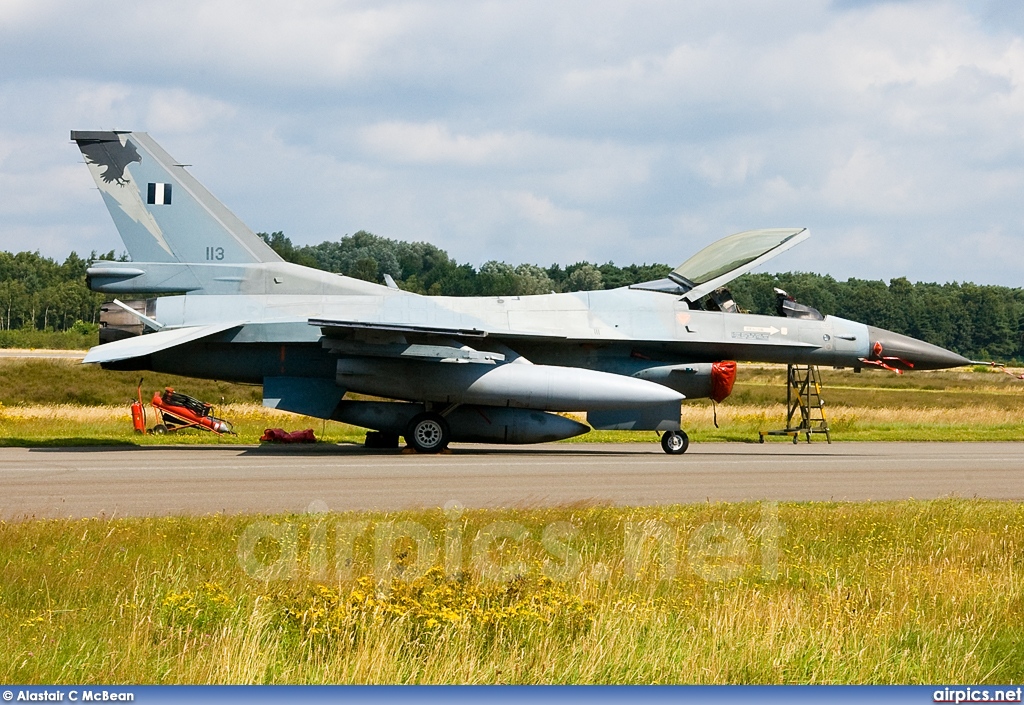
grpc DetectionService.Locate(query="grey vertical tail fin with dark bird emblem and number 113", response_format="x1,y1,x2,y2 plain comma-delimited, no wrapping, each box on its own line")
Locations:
71,130,281,264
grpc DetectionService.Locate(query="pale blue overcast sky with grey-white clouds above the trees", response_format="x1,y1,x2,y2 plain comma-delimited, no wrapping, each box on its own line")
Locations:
0,0,1024,286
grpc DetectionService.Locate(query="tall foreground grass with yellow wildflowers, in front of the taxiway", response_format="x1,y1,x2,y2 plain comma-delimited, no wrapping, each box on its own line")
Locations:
0,499,1024,683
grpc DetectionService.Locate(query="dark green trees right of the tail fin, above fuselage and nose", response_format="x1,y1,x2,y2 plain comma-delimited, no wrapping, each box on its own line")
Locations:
260,231,1024,362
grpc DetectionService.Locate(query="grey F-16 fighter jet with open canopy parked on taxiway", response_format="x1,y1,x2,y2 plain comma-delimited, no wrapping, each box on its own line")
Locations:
71,131,969,454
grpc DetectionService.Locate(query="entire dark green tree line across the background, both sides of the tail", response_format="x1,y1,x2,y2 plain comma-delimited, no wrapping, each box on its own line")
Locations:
0,231,1024,362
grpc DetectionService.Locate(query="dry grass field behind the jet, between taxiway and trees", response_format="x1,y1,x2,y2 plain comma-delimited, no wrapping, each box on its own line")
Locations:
0,360,1024,445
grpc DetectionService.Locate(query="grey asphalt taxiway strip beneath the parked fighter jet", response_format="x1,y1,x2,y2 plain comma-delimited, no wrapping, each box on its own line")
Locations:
0,443,1024,521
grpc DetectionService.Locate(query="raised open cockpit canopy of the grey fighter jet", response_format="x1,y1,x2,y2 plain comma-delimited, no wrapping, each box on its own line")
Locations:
634,227,810,302
